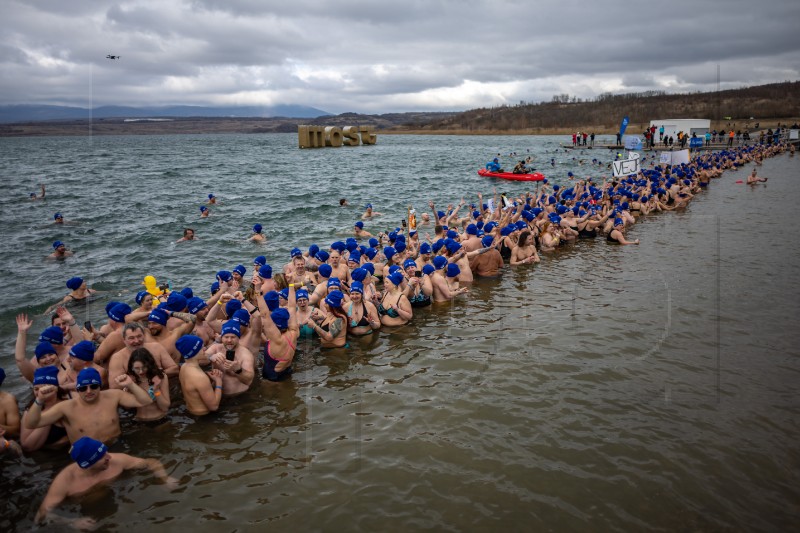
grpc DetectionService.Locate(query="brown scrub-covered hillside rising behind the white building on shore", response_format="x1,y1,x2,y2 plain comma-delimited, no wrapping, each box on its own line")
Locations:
395,82,800,134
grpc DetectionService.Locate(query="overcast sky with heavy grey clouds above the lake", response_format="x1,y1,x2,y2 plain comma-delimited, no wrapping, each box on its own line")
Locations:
0,0,800,113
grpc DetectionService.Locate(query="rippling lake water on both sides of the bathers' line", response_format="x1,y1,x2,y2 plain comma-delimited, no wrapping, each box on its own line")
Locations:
0,134,800,531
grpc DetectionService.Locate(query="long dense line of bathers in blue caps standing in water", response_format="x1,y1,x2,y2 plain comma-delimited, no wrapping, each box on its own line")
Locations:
0,137,789,521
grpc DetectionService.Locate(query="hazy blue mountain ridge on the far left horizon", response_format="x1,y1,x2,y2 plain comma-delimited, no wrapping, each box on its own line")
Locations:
0,104,330,124
